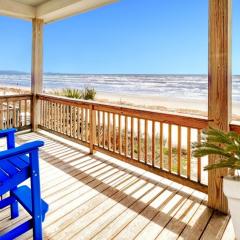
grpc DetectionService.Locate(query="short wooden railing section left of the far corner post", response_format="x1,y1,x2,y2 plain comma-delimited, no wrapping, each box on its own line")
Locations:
0,94,32,130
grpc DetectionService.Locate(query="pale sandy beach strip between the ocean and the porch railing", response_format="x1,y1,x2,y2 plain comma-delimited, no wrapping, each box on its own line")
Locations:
0,85,240,121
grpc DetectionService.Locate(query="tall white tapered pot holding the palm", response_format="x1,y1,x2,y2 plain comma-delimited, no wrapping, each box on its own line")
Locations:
223,176,240,240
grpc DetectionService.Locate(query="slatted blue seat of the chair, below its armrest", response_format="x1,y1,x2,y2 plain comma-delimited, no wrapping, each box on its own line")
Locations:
0,155,30,195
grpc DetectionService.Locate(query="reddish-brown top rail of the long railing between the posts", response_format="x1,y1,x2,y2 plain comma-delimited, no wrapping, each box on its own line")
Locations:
38,94,208,129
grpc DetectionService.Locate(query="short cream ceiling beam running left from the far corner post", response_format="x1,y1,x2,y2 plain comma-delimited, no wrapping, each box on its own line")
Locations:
0,0,36,20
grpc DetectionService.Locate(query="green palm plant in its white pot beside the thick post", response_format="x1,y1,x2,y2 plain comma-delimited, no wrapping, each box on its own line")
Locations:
193,128,240,239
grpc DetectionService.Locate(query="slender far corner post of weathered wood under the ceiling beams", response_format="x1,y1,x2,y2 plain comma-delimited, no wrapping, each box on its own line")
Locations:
31,19,44,131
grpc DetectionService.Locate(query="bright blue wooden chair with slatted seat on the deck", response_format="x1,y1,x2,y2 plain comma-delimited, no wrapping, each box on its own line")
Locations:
0,129,48,240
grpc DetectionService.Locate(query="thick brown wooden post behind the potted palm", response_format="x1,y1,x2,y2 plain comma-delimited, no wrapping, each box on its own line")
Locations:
208,0,232,213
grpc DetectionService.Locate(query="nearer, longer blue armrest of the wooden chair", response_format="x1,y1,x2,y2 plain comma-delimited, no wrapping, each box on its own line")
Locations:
0,141,44,160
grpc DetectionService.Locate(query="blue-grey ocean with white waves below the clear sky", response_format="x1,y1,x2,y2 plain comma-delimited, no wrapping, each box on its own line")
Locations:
0,74,240,102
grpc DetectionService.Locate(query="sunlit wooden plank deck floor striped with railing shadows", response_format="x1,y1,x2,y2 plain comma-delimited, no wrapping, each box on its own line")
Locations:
0,133,234,240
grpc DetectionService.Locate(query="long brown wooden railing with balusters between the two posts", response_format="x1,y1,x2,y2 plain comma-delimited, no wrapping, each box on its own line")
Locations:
37,94,208,193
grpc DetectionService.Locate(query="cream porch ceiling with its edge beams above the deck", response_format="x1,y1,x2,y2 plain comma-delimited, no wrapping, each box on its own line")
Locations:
0,0,117,23
